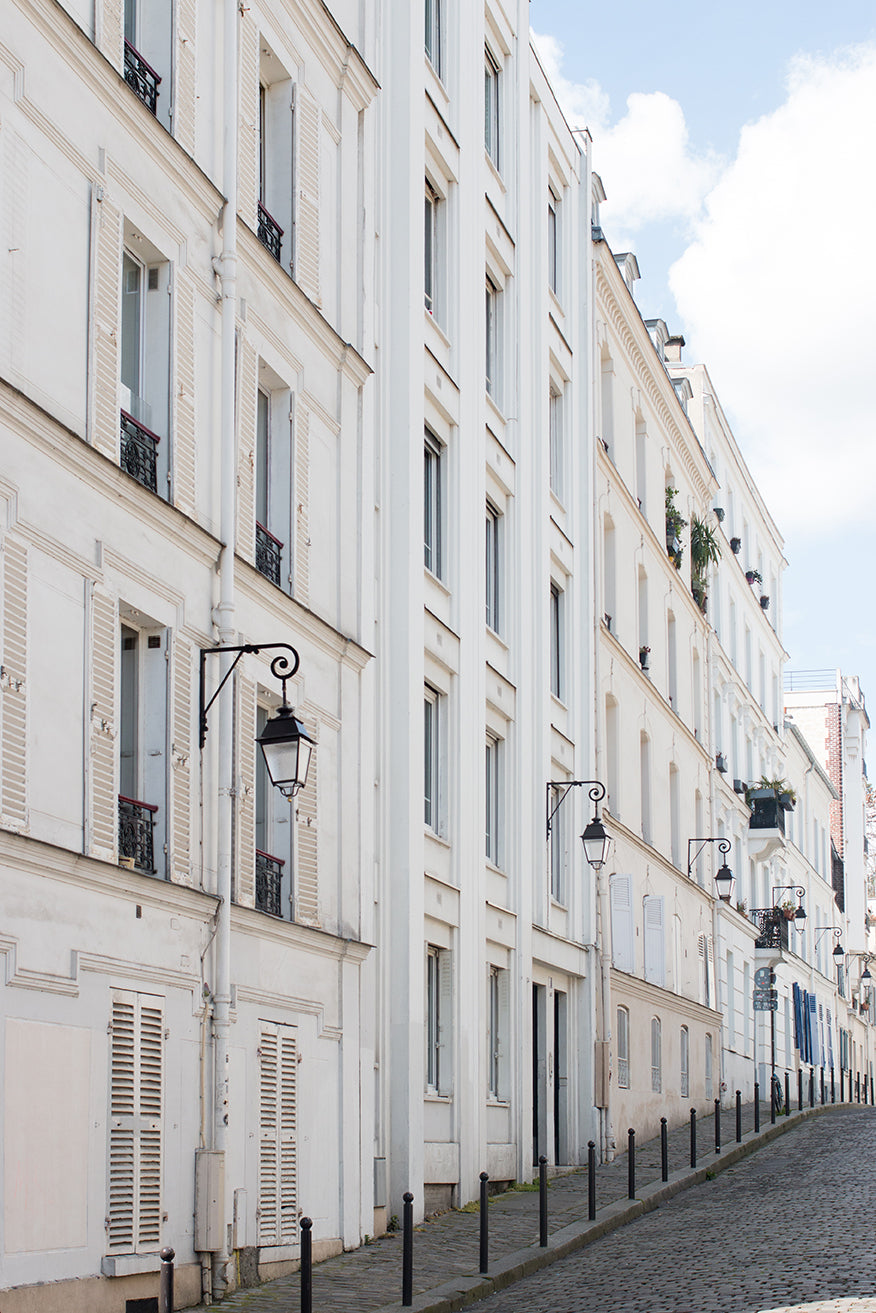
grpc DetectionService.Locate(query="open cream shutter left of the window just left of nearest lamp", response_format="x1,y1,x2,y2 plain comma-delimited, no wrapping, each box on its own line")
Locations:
89,588,118,861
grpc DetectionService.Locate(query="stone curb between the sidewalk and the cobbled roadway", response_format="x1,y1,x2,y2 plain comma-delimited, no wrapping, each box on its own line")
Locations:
372,1103,844,1313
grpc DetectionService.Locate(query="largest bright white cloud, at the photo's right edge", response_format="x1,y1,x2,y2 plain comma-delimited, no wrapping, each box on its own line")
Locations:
670,46,876,533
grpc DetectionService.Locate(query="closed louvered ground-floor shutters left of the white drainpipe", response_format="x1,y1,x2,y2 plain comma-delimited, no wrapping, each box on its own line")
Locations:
106,990,164,1254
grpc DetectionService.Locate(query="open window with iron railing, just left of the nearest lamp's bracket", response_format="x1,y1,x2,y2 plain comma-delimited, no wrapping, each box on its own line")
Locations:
118,624,168,876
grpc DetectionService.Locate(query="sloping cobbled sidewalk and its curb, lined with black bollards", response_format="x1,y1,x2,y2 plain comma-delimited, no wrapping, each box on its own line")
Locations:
190,1100,863,1313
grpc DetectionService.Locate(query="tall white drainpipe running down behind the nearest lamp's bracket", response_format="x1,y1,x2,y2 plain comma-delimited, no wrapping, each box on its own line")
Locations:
213,0,239,1299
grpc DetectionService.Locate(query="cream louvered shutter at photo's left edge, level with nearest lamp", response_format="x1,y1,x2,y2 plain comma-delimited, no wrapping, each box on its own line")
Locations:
0,537,28,830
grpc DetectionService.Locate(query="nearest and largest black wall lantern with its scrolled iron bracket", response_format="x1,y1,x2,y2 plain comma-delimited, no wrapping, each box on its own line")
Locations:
198,643,314,798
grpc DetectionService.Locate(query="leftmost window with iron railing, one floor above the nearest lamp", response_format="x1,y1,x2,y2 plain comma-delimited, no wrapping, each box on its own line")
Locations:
120,242,171,496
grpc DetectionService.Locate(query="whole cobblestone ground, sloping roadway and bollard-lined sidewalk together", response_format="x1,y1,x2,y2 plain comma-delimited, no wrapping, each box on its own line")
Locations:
191,1106,876,1313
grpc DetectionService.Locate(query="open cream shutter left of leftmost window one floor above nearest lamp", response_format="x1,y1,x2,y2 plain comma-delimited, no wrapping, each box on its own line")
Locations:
89,188,122,461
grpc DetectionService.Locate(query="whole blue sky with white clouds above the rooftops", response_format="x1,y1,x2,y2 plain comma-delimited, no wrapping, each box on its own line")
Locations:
529,0,876,719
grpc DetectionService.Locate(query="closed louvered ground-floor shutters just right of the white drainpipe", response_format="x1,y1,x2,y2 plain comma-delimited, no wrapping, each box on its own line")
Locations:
257,1022,298,1245
